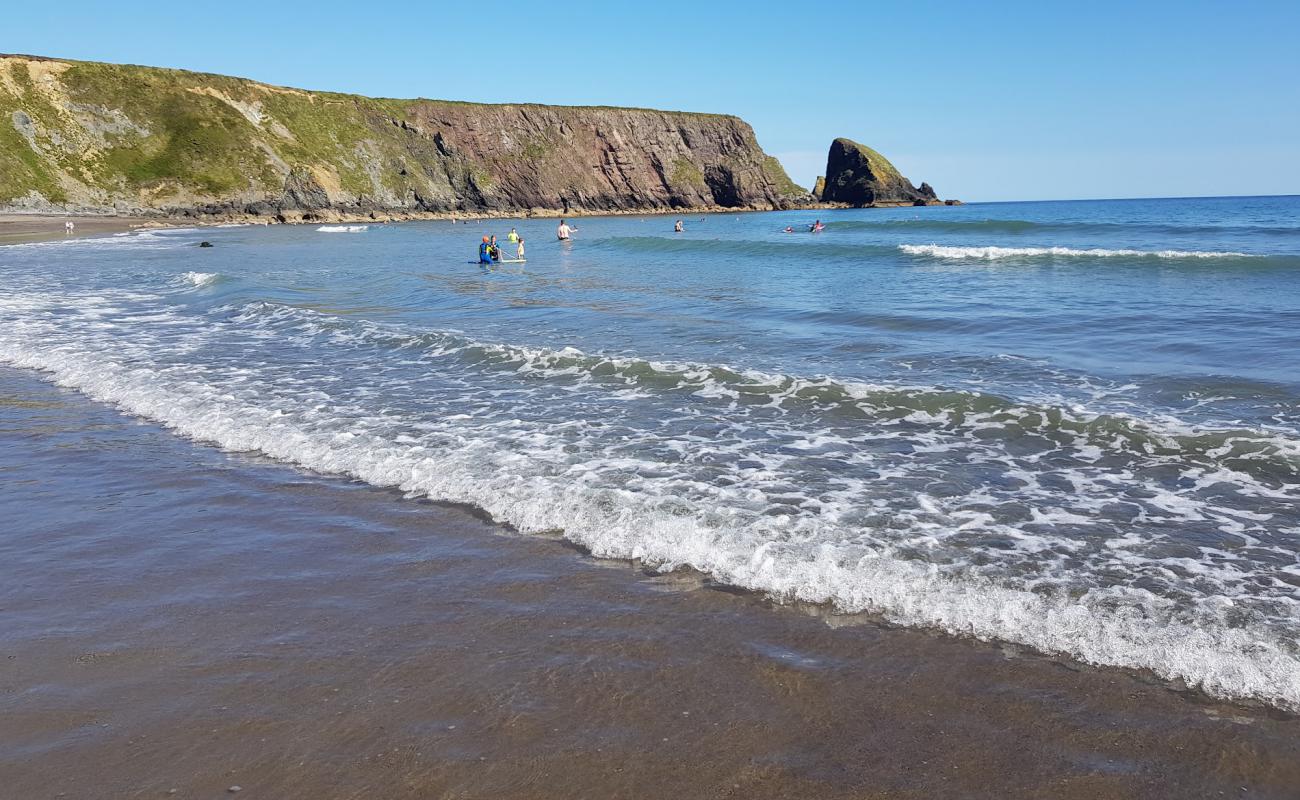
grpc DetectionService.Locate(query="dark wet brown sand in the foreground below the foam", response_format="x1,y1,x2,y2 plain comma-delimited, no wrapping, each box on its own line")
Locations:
0,368,1300,800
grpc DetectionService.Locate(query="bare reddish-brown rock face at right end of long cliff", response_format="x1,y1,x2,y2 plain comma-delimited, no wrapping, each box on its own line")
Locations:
410,103,798,211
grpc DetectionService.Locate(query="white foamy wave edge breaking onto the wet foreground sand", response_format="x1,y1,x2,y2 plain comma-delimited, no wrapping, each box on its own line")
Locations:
0,318,1300,708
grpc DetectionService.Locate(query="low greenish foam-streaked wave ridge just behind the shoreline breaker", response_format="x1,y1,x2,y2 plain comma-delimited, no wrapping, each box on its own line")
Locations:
228,302,1300,485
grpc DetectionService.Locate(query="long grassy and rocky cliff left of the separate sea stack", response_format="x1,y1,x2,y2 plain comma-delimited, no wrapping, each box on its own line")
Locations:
0,56,809,219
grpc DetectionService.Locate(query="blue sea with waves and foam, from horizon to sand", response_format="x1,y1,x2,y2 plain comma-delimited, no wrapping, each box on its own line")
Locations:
0,198,1300,708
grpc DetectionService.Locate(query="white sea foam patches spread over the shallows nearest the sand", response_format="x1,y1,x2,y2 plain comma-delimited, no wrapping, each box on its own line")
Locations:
0,295,1300,708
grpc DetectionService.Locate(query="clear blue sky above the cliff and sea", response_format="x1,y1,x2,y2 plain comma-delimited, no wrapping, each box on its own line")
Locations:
0,0,1300,200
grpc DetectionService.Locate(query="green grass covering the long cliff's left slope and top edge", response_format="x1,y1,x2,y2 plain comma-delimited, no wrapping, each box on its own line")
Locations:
0,57,803,204
